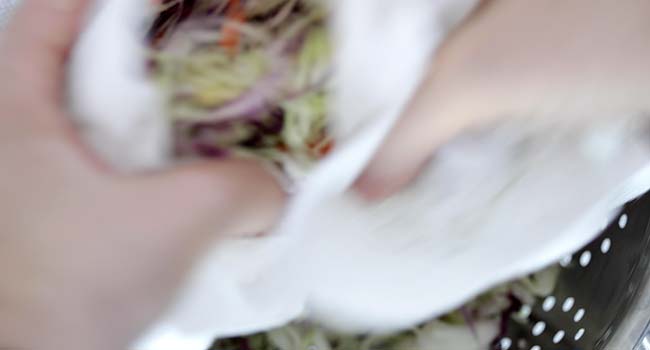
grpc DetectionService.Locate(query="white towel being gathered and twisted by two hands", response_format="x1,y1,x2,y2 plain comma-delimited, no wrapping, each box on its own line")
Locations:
70,0,650,350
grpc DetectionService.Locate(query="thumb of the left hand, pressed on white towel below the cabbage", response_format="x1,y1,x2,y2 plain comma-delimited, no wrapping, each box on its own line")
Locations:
119,160,285,244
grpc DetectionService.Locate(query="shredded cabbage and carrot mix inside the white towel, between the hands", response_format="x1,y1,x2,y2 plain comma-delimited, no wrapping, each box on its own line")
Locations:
149,0,333,179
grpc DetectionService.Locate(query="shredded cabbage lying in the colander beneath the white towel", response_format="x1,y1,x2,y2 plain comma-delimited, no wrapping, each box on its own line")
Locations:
206,266,559,350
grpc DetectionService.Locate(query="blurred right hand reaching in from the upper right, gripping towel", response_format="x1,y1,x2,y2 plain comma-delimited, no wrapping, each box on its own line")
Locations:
357,0,650,199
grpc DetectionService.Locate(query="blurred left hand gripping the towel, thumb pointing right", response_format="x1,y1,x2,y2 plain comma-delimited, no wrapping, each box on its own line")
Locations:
0,0,283,350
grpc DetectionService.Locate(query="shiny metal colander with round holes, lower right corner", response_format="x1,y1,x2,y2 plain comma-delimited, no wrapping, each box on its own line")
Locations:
492,194,650,350
